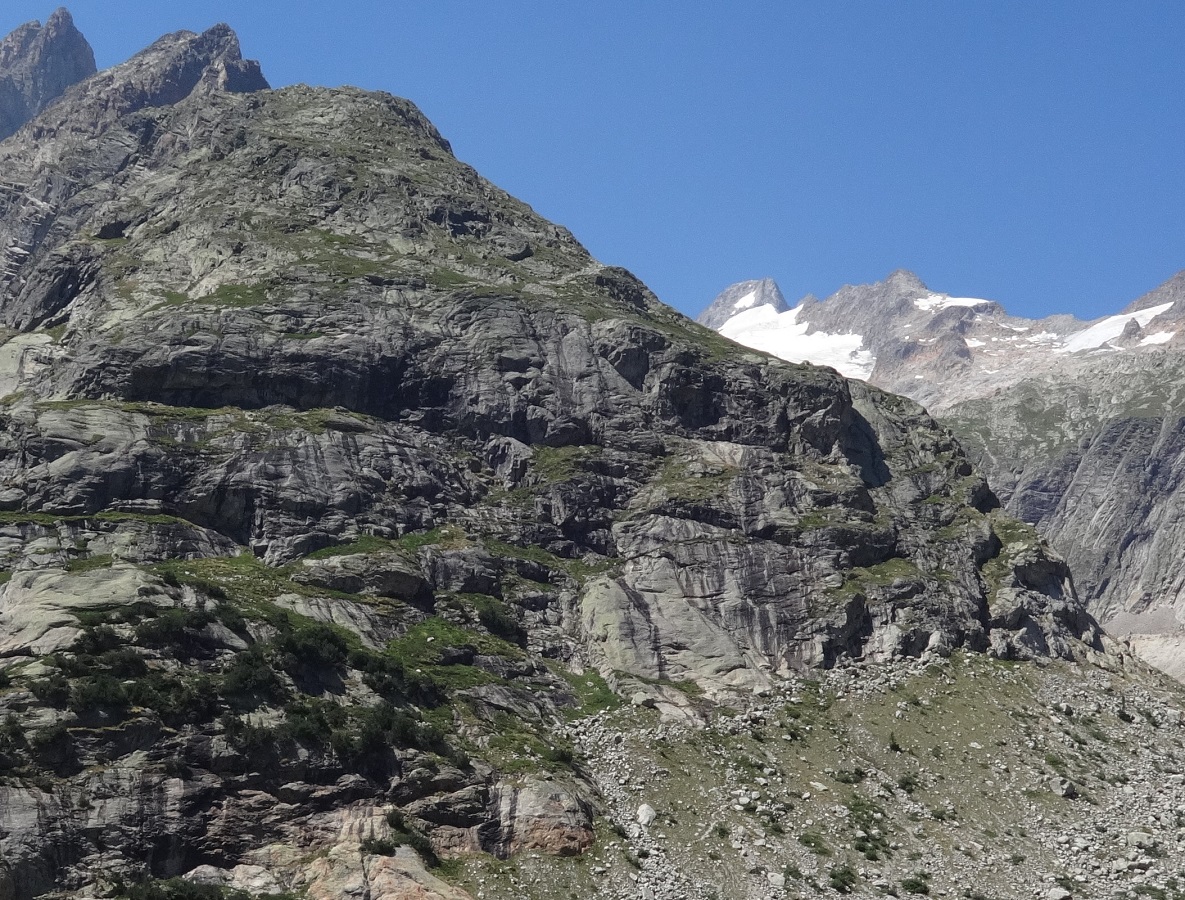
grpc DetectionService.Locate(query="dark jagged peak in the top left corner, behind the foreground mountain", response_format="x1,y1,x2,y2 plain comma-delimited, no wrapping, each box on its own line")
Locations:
0,9,95,140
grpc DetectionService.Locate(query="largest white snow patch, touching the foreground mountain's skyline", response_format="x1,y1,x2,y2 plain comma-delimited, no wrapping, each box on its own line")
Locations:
719,305,877,379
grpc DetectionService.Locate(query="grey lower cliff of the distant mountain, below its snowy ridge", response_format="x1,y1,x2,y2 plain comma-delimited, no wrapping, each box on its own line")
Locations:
947,351,1185,677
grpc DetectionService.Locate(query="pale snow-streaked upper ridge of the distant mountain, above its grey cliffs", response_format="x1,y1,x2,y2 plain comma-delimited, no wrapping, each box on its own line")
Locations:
699,270,1185,414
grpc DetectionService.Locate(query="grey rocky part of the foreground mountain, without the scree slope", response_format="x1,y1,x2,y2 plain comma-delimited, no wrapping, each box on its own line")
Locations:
0,12,1098,898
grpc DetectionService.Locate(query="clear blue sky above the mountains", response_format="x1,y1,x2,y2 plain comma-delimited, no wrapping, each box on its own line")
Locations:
0,0,1185,318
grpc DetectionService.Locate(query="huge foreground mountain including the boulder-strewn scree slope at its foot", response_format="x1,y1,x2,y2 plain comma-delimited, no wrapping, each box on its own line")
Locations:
0,12,1185,900
